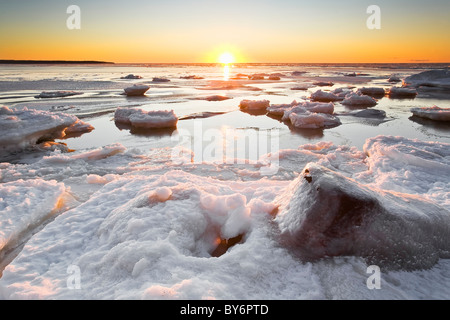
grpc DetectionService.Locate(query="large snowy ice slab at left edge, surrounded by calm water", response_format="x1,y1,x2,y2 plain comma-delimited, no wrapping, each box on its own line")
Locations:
0,107,93,152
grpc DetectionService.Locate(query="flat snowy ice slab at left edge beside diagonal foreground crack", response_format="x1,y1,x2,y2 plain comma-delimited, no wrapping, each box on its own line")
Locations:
0,179,66,276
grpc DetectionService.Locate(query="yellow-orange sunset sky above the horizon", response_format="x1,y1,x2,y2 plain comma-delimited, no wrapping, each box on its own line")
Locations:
0,0,450,63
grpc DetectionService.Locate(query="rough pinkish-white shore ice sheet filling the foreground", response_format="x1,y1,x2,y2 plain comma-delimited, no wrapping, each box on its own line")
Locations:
0,136,450,300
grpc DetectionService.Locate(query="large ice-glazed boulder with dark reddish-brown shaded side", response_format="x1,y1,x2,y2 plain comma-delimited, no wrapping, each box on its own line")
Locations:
276,163,450,270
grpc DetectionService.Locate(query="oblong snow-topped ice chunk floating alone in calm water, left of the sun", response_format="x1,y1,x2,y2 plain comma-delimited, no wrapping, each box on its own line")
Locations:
114,107,178,129
